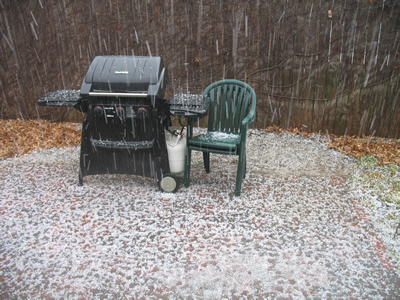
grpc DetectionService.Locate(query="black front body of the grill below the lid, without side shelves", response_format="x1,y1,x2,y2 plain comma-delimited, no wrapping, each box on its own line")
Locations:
79,97,169,184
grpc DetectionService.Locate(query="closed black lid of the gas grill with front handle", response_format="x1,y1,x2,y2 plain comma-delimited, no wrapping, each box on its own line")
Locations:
80,56,168,98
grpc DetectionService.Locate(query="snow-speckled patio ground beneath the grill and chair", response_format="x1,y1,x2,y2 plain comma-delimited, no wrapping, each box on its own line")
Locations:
0,130,400,299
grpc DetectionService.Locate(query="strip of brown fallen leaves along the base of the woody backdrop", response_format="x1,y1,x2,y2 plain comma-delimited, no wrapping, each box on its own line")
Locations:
0,119,400,164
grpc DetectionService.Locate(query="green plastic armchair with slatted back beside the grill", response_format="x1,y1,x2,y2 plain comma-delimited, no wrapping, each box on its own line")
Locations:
184,79,257,196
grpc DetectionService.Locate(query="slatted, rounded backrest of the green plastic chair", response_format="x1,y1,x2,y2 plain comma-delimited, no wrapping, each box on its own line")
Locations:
203,79,257,134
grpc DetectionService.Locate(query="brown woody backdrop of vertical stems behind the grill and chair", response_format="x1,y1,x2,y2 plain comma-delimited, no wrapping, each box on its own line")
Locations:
0,0,400,138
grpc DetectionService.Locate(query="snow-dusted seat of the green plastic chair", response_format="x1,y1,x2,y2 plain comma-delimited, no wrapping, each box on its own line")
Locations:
189,131,240,152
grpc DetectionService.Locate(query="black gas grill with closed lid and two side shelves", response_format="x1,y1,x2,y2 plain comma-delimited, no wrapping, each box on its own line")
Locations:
38,56,208,192
